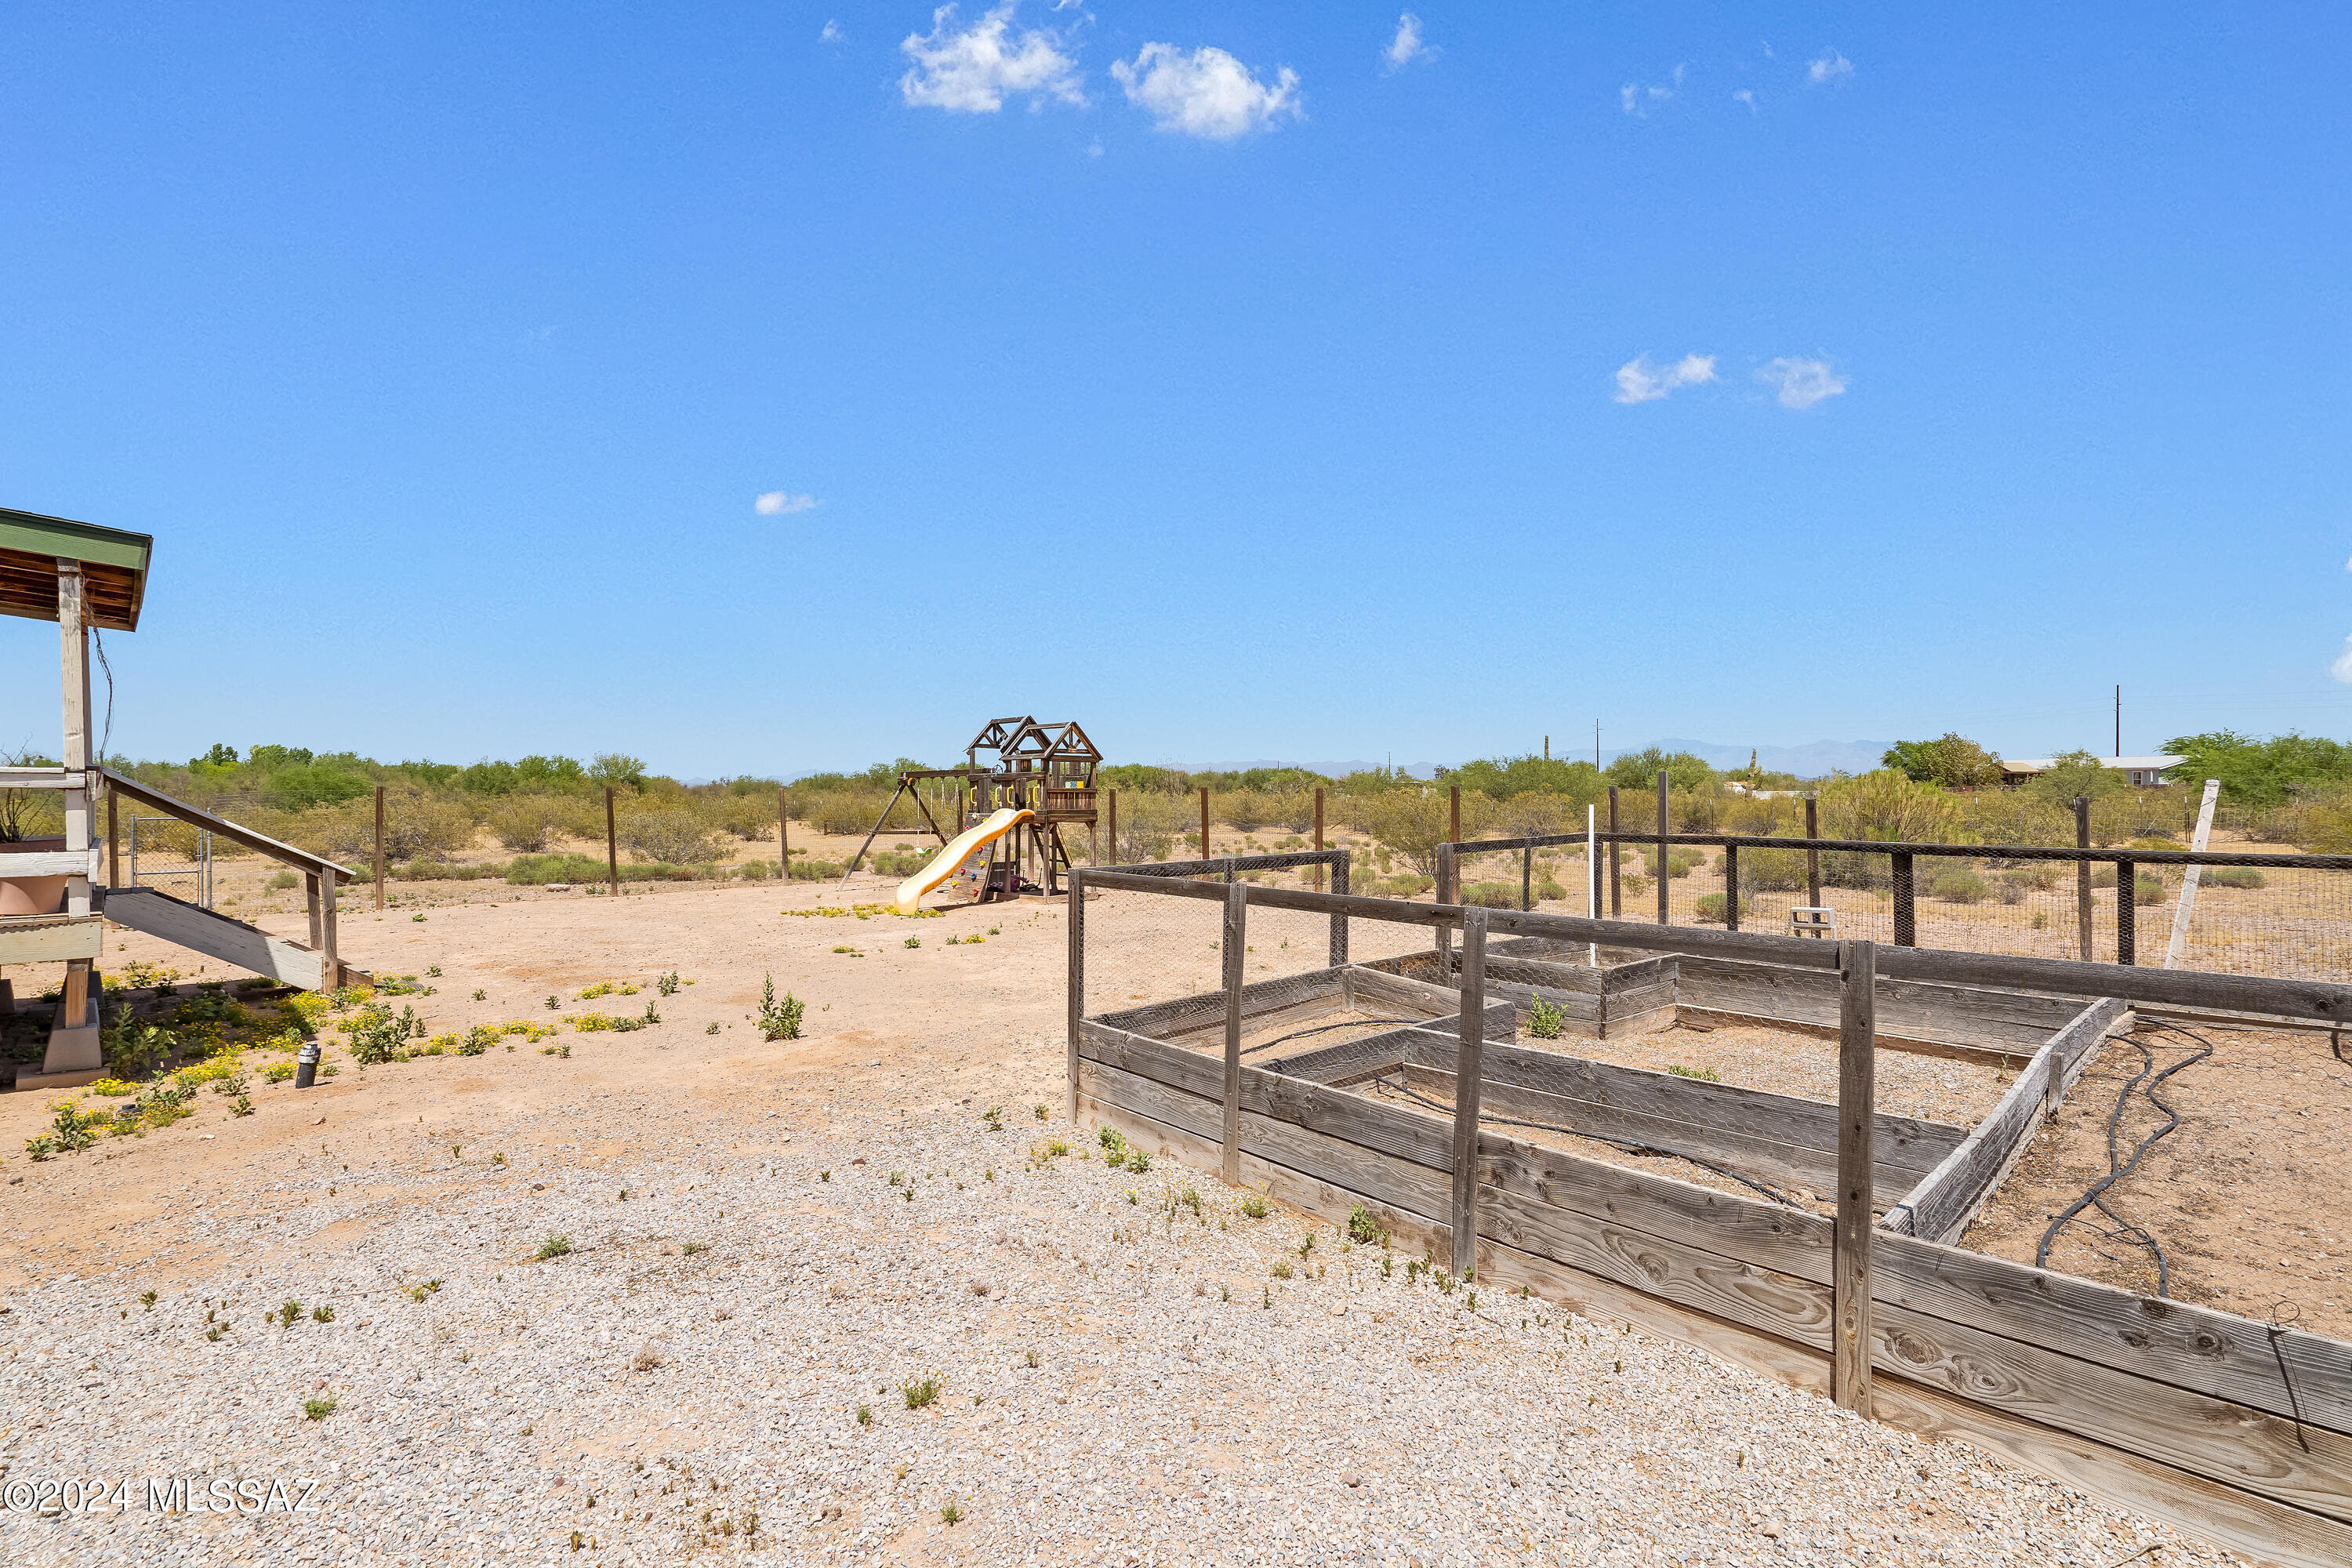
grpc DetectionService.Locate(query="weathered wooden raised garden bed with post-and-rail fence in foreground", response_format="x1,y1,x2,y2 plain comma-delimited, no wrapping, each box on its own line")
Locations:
1068,867,2352,1568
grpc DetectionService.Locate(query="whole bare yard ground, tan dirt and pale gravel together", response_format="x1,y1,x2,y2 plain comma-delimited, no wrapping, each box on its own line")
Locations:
0,879,2258,1568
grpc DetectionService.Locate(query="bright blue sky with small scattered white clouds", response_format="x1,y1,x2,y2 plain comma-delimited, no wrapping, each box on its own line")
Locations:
0,0,2352,776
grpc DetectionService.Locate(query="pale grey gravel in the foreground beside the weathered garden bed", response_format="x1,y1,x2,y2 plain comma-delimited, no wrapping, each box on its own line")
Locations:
0,1039,2223,1568
